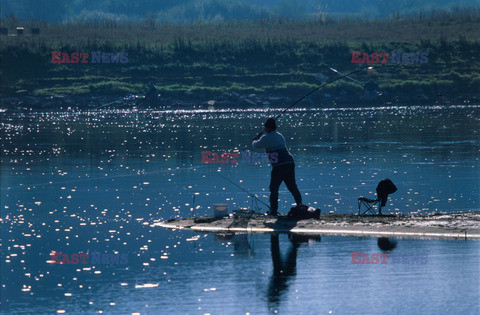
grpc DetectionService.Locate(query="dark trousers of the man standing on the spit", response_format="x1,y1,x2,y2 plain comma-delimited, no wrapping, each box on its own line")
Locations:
270,163,302,212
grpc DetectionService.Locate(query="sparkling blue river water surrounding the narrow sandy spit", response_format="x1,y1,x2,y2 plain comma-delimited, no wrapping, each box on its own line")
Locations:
0,106,480,314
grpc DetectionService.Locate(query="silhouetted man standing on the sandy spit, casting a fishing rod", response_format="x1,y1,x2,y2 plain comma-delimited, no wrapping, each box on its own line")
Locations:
252,118,302,215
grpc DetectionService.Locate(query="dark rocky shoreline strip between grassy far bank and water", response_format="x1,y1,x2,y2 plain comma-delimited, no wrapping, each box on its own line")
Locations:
0,93,480,110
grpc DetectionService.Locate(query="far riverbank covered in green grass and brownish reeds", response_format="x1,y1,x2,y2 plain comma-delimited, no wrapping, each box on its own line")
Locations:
0,10,480,101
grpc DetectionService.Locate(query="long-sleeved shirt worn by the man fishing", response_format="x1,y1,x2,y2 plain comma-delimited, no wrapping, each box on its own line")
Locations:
252,131,295,167
